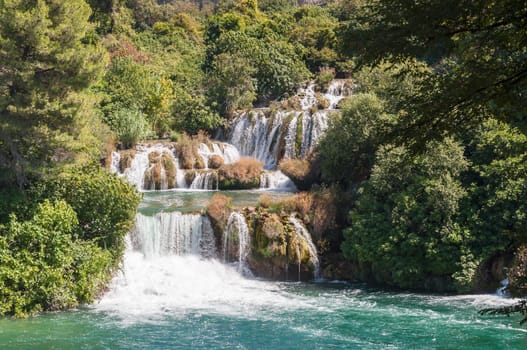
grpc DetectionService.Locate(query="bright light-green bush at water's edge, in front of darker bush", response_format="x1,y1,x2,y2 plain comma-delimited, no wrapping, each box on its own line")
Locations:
0,200,111,317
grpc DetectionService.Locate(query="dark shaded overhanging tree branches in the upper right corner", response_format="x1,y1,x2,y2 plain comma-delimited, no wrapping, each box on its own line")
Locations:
343,0,527,143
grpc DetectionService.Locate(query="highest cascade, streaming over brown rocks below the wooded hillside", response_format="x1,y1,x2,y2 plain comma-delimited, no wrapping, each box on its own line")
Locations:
227,80,352,169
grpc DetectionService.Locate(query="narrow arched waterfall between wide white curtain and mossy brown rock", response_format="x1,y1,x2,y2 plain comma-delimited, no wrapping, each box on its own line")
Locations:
223,212,250,273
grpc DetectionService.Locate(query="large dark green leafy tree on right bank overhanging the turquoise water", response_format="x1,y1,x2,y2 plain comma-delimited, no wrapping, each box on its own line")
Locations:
342,139,477,291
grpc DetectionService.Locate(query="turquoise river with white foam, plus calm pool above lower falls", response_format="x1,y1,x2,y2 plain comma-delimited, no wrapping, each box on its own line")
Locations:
0,191,527,350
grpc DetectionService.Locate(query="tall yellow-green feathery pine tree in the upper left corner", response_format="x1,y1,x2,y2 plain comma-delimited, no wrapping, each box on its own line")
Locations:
0,0,104,186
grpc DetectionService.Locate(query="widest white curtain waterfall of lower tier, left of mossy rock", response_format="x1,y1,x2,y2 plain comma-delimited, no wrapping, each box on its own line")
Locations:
130,212,216,258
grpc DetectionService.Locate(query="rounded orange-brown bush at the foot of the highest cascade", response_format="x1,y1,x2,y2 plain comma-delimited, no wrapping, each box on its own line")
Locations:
218,158,263,190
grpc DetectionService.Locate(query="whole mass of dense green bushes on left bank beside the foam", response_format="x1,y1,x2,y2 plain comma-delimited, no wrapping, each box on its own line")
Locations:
0,169,139,316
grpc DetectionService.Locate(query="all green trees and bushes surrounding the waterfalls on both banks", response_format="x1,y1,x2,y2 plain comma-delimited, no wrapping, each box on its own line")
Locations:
0,0,527,316
